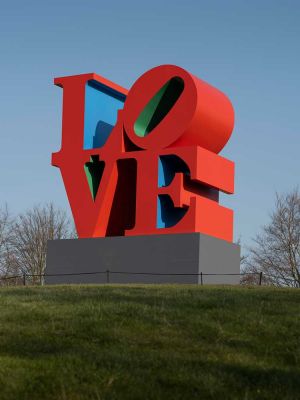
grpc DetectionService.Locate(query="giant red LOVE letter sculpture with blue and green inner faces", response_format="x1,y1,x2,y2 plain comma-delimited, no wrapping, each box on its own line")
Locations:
45,65,241,284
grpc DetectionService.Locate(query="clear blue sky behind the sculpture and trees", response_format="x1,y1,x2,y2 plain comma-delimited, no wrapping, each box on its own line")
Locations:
0,0,300,244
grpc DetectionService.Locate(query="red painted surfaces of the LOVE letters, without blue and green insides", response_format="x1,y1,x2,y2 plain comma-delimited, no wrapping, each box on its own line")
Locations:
52,65,234,241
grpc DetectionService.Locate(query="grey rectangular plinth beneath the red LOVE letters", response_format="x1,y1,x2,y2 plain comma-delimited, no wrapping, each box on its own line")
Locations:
45,233,240,284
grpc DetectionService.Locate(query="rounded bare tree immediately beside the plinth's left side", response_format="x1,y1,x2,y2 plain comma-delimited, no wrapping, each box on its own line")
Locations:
12,203,75,283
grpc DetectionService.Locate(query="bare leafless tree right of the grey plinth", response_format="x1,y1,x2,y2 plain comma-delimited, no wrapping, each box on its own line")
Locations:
244,189,300,287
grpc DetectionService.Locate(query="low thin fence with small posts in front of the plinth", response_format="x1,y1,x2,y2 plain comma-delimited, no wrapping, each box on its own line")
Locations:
0,269,262,286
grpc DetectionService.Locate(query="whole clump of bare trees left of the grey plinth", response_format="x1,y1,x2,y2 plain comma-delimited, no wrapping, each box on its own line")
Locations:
0,203,76,284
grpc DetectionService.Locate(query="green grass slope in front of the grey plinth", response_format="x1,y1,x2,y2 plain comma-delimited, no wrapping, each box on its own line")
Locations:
0,285,300,400
